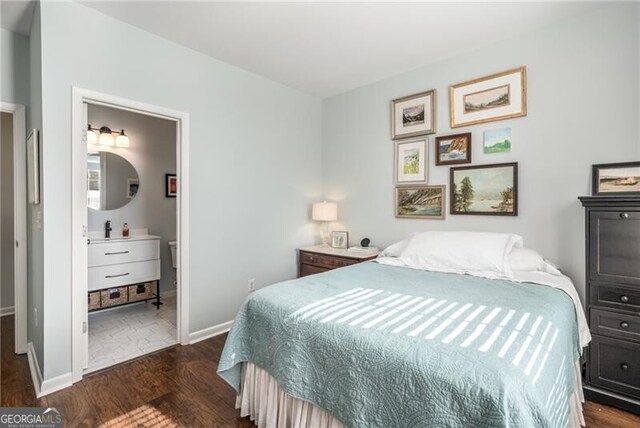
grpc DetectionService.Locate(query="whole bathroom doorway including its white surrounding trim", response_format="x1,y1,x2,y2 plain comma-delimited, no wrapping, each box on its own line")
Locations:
72,88,188,382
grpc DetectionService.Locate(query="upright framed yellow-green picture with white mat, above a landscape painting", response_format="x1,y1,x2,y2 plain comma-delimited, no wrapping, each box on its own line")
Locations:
394,138,429,185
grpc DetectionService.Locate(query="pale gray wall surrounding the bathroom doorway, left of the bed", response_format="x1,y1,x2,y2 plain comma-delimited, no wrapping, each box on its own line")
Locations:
35,2,322,379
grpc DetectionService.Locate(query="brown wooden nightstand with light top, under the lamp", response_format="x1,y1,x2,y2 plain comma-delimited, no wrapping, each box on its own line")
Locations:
298,246,378,278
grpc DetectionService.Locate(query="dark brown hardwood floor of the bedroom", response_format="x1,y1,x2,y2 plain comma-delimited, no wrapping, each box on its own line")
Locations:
0,316,640,428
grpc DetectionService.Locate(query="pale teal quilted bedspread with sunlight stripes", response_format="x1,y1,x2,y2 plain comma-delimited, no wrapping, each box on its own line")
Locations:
218,262,580,427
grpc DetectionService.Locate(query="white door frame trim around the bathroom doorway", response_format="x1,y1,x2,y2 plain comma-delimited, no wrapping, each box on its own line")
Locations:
71,87,189,382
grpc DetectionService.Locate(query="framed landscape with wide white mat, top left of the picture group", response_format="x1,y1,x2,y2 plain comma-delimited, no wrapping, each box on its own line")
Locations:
391,89,436,140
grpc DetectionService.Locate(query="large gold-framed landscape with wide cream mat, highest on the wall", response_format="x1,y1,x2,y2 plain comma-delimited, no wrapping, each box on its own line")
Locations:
449,66,527,128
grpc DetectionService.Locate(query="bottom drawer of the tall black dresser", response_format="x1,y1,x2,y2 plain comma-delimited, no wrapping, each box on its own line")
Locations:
589,335,640,398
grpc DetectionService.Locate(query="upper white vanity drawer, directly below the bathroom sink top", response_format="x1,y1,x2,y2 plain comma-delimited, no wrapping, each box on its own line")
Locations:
89,239,160,267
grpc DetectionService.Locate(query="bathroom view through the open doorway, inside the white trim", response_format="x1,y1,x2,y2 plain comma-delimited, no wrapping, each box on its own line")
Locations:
84,103,178,373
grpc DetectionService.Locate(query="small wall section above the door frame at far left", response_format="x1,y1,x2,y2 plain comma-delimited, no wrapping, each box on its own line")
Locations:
0,28,29,106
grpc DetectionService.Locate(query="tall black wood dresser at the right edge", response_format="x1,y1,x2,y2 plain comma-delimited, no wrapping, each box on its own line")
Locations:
580,196,640,414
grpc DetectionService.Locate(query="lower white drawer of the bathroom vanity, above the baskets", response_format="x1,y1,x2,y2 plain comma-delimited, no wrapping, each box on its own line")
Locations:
88,260,160,291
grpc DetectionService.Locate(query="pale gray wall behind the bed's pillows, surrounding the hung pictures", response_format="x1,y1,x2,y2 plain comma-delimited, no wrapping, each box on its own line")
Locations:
322,3,639,304
